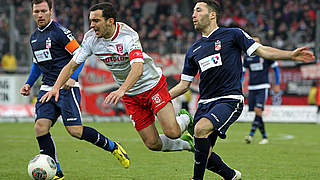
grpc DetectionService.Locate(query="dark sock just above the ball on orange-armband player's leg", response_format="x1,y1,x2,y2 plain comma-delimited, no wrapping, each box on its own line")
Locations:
37,133,57,162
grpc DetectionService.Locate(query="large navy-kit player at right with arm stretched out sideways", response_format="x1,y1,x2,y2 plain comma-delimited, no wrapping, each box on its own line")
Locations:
169,0,314,180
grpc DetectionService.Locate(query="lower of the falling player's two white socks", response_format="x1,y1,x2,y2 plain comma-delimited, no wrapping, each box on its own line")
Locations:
159,134,191,151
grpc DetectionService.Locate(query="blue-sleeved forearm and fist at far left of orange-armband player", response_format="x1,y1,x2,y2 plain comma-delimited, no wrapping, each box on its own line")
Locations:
20,63,42,96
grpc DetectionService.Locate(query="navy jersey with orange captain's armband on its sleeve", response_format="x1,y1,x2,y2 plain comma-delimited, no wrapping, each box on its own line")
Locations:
30,21,82,86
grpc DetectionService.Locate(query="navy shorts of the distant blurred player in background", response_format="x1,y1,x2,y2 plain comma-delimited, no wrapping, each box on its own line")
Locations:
248,89,268,111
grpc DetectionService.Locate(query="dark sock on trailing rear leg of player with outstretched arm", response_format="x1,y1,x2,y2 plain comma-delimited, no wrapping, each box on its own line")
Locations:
207,152,235,180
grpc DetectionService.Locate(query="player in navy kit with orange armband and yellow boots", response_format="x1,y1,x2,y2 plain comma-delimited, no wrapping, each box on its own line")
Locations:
20,0,130,180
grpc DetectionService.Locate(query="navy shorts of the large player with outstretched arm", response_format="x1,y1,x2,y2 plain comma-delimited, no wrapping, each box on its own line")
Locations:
194,99,243,139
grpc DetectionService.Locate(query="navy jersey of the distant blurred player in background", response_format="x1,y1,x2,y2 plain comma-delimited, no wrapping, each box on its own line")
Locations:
243,56,279,90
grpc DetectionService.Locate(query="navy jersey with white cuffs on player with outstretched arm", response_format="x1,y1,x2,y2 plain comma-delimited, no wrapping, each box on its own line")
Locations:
181,27,260,103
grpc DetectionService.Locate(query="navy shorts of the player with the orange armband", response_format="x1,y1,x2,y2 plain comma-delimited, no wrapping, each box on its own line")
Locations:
36,87,82,126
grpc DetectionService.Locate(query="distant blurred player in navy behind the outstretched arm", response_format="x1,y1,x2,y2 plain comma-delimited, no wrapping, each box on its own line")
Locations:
242,36,280,144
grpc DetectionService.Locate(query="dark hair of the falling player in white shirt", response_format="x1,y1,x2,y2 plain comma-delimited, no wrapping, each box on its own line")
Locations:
89,2,117,22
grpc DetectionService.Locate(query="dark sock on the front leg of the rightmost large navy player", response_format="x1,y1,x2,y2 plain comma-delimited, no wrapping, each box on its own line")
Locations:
193,137,210,180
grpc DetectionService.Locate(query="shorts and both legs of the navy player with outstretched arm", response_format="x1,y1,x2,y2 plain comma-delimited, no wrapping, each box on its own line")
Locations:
194,99,243,180
